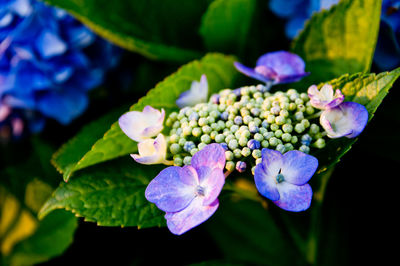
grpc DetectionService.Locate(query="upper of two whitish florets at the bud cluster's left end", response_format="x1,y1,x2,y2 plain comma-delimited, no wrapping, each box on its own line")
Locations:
118,105,165,142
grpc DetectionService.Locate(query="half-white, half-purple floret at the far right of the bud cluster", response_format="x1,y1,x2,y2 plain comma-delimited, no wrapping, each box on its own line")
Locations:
320,102,368,138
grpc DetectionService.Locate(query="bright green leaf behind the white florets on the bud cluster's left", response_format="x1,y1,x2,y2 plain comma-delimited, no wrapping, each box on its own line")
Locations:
53,54,239,181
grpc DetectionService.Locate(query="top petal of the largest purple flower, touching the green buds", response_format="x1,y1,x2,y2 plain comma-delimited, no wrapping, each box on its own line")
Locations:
191,143,225,172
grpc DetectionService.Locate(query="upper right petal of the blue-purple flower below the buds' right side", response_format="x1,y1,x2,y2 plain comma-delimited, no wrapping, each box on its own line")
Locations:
281,151,318,185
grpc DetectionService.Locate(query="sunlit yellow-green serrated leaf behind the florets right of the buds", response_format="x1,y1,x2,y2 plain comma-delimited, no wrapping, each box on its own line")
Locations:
314,68,400,173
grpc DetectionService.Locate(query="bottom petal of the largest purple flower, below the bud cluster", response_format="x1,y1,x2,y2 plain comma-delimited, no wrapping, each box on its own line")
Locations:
165,197,219,235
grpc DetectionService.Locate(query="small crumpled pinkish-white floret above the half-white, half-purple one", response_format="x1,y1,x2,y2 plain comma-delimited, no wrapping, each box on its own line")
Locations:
307,84,344,110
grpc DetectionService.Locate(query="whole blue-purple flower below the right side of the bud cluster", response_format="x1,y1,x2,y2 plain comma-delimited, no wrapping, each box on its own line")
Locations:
254,149,318,212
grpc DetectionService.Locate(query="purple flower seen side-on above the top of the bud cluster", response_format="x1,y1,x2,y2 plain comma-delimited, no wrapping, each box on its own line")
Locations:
234,51,309,85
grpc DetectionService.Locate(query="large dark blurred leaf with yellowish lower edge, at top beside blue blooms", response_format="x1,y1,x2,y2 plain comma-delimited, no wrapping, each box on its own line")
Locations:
45,0,209,62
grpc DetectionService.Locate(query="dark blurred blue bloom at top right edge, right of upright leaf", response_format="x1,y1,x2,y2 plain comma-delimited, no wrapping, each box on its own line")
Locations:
374,0,400,70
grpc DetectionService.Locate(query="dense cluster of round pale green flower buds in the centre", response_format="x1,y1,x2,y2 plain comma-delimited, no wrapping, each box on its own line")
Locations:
166,85,326,175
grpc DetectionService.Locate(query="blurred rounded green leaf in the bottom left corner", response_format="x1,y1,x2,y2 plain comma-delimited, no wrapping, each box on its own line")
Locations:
7,211,78,265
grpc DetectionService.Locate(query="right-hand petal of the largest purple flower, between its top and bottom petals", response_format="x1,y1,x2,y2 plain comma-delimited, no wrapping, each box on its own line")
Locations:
197,166,225,205
